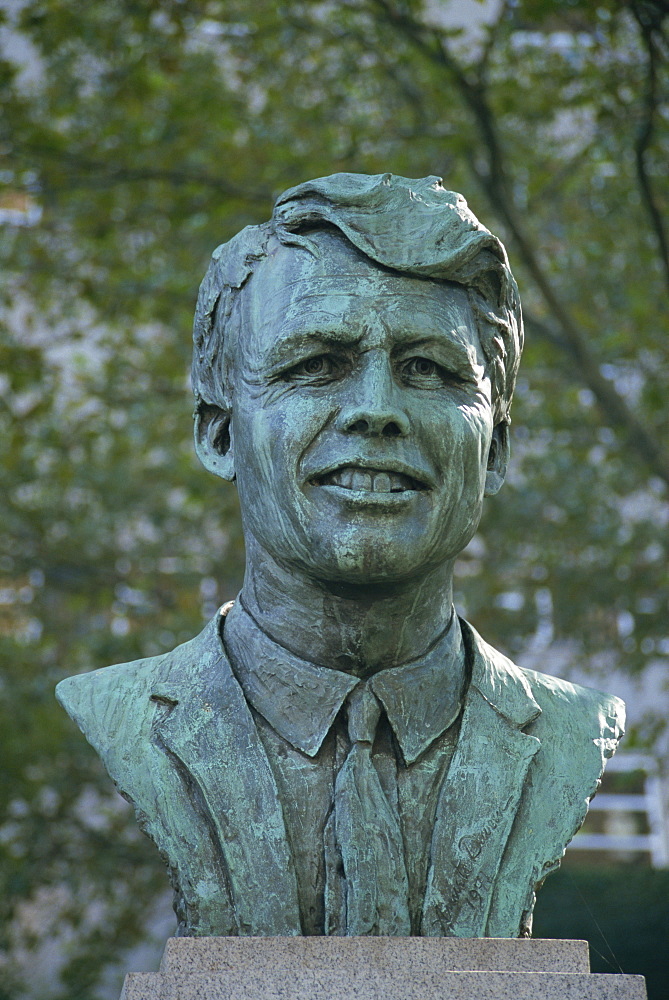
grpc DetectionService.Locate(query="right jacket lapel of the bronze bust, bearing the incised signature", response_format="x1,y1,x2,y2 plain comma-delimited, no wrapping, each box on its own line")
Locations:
421,622,541,937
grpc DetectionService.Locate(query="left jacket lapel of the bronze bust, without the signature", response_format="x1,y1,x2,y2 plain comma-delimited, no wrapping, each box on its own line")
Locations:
152,615,301,936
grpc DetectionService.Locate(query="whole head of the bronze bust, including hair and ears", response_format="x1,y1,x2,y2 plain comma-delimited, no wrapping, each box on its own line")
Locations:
193,174,523,584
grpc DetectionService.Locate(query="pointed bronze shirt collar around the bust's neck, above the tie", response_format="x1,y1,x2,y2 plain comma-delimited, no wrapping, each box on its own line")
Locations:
222,601,465,764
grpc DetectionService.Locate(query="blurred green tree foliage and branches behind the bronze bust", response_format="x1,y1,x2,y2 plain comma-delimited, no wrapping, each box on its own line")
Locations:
0,0,669,1000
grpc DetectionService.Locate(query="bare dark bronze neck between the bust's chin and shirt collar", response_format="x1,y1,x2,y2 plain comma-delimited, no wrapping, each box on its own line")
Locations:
241,546,453,677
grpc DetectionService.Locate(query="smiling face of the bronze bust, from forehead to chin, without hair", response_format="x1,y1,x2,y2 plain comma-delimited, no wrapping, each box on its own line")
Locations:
204,234,505,584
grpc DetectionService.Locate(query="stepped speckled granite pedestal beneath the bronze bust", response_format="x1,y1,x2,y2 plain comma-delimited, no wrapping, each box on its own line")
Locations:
121,937,646,1000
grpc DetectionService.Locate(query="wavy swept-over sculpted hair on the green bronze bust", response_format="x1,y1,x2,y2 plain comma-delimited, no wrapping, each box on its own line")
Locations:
192,173,523,421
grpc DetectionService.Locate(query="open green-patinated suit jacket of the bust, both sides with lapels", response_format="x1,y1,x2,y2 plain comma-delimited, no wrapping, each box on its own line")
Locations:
57,615,624,937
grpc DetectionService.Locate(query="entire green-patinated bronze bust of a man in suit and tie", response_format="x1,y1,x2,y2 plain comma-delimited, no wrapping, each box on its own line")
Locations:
58,174,623,937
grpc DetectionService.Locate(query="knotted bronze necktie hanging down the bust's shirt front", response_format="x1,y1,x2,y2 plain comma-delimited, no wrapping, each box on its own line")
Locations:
326,684,411,936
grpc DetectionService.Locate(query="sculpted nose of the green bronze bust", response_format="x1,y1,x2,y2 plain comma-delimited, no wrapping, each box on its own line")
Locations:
337,363,409,438
